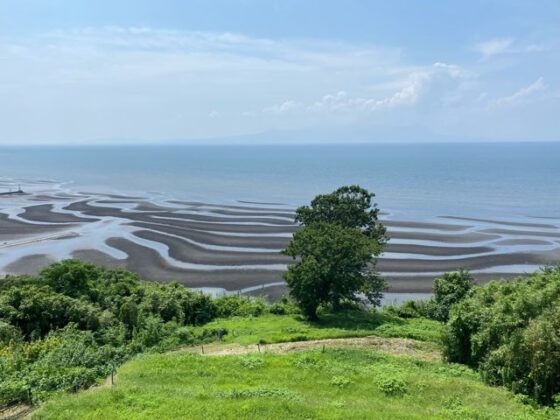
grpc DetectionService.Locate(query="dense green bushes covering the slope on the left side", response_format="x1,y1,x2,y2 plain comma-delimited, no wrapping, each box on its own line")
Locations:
0,260,291,406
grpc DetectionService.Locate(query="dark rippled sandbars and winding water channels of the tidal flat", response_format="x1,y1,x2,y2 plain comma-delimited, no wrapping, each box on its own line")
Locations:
0,181,560,298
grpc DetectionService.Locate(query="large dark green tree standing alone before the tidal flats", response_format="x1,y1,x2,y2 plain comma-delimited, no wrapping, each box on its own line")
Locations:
283,186,387,319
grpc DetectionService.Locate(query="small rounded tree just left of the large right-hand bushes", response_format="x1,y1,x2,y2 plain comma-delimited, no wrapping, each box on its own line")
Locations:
433,269,474,322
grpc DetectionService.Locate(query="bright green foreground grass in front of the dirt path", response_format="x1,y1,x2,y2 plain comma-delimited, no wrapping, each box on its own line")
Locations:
33,348,546,419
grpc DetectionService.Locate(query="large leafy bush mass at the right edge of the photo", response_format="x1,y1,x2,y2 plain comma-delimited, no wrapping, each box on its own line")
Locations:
444,266,560,404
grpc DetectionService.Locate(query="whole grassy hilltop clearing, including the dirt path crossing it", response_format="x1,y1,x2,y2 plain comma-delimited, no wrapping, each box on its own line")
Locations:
33,313,552,419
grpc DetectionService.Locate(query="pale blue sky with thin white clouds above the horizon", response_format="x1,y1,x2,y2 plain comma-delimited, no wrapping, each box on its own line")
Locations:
0,0,560,145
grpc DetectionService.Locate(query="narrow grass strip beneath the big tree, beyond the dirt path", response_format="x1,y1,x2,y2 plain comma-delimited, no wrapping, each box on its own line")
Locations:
191,310,442,345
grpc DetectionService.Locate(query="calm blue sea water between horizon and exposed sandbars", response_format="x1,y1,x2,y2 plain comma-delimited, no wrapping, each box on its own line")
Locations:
0,143,560,220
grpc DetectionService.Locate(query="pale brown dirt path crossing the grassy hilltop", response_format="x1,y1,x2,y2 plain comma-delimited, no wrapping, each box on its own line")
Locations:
175,336,441,362
